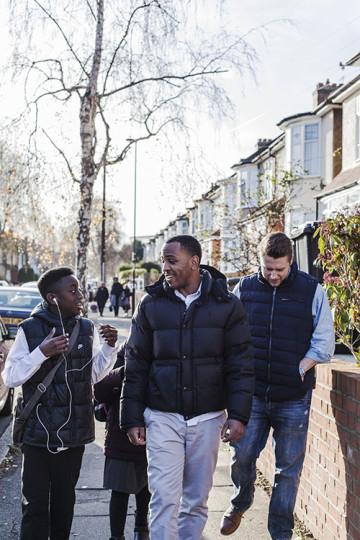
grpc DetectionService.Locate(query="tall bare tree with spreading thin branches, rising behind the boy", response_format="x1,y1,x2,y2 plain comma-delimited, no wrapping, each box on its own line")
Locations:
10,0,262,292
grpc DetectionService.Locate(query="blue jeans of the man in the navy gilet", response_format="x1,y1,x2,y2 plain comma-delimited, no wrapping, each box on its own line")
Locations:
231,390,312,540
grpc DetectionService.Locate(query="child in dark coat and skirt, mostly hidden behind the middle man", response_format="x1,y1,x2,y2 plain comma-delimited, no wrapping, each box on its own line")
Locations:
94,342,150,540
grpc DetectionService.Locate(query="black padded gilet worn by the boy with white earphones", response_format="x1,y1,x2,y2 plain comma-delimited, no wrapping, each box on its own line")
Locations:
20,302,95,447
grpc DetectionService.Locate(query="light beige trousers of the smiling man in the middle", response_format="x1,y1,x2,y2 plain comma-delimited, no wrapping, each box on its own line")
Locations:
144,409,226,540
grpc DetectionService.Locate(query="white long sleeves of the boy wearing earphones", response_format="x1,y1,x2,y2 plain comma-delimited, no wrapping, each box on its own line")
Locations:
2,327,118,388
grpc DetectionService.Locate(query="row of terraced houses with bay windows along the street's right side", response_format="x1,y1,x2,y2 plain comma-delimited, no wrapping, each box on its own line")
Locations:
146,53,360,278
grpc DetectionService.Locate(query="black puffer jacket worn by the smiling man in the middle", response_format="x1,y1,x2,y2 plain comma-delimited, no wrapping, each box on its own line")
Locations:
121,267,254,429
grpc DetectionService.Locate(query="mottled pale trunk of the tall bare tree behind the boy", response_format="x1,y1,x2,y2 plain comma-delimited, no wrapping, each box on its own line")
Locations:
76,0,104,292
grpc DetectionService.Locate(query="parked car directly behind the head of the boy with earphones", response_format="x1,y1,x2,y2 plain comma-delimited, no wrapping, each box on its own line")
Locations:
0,287,42,339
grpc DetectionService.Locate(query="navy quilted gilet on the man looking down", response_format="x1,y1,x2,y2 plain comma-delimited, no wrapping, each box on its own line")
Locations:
240,262,318,401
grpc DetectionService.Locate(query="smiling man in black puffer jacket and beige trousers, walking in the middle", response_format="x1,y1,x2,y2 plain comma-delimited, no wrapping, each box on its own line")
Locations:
121,235,254,540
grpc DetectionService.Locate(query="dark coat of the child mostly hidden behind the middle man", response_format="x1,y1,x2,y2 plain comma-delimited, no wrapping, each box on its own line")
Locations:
94,343,146,461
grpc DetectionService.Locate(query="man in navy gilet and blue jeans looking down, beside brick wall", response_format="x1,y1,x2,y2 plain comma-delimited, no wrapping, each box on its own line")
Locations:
220,232,334,540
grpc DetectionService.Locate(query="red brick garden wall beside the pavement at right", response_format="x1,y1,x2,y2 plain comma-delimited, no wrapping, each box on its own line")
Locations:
258,360,360,540
